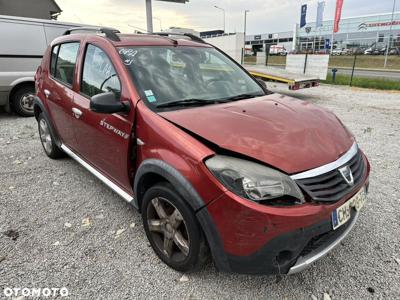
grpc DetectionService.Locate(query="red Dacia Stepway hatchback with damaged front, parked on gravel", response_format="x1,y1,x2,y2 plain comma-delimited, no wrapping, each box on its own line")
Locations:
34,28,370,274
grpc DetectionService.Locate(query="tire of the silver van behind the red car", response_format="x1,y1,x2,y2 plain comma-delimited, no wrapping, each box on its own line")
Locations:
11,85,35,117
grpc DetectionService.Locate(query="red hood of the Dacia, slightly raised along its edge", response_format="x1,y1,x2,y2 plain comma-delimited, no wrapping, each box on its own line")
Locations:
160,94,354,174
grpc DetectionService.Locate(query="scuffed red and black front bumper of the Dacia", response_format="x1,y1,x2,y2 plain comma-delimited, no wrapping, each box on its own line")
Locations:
206,178,368,274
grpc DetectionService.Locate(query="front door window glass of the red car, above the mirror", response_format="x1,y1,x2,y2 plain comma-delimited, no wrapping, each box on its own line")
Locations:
81,44,121,98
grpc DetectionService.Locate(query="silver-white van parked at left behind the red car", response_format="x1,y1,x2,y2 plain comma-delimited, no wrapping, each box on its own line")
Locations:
0,15,82,116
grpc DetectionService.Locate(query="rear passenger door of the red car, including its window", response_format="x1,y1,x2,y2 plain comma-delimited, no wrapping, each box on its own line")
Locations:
43,42,79,148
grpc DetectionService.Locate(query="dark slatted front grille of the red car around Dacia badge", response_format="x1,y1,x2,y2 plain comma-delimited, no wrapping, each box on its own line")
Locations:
296,151,365,202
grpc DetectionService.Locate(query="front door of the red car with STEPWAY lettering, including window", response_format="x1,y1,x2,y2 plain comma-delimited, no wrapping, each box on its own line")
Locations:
72,44,134,192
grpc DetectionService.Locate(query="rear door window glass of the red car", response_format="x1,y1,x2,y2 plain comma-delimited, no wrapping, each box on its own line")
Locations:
54,43,79,86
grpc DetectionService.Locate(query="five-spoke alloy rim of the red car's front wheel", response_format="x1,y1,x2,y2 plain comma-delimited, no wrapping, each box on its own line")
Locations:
147,197,190,262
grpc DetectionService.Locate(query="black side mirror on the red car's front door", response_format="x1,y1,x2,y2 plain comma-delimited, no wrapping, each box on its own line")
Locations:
90,92,130,114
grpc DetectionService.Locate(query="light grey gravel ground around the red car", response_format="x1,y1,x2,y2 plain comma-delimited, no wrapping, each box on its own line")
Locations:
0,85,400,299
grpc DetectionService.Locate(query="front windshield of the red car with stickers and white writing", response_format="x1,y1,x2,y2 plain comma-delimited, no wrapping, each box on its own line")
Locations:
119,47,265,108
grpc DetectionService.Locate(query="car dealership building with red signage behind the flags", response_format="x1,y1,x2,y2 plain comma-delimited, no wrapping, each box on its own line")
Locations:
246,12,400,51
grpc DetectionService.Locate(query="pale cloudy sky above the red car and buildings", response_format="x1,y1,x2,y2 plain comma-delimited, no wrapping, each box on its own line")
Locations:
56,0,400,34
